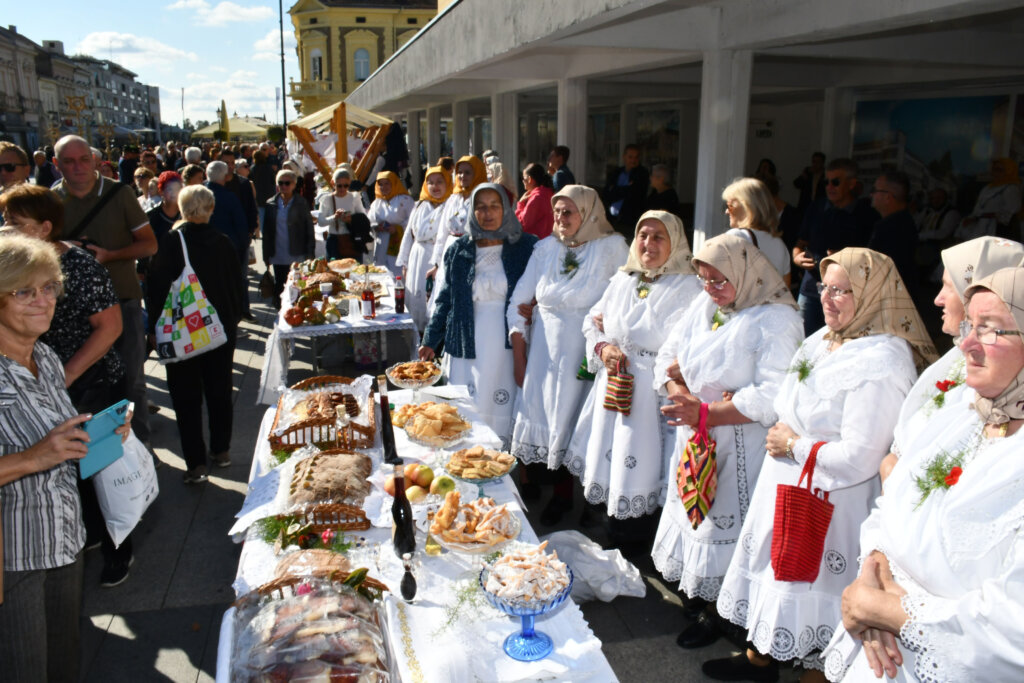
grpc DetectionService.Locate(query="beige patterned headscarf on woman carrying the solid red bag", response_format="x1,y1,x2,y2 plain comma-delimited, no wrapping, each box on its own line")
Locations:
821,247,938,372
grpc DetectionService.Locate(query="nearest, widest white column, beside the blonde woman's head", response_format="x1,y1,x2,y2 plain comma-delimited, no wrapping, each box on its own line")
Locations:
693,50,754,251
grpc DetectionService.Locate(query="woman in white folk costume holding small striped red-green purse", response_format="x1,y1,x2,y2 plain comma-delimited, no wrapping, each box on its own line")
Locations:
565,211,700,538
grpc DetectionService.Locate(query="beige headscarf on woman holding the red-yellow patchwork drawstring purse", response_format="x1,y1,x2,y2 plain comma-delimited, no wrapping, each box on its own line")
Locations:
693,234,798,312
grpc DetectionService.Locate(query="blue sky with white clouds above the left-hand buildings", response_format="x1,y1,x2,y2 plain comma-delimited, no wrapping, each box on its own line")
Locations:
7,0,299,124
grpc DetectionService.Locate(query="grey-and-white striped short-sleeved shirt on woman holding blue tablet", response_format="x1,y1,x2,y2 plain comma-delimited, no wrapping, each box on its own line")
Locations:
0,342,85,571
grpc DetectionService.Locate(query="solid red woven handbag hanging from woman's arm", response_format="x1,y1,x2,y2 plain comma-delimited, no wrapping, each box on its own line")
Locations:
771,441,835,582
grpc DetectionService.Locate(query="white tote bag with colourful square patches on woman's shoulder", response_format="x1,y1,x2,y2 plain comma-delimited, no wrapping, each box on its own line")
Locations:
157,230,227,364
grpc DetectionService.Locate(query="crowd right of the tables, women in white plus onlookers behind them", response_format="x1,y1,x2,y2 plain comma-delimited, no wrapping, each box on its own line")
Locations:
399,150,1024,681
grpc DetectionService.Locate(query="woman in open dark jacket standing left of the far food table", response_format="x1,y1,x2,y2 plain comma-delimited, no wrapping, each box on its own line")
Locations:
263,169,316,307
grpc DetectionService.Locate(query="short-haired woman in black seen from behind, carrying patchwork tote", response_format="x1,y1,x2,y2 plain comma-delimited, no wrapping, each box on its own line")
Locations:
145,185,244,483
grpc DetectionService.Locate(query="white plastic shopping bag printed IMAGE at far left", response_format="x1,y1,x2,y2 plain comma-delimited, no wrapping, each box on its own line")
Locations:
92,432,160,546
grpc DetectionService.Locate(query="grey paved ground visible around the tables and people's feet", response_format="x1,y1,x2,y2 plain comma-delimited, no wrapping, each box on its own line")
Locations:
82,253,797,683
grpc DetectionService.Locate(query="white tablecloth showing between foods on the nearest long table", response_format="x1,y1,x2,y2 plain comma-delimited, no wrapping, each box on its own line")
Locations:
217,386,617,683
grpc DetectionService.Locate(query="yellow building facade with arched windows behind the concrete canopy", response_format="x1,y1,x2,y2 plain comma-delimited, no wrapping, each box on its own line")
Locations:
288,0,438,116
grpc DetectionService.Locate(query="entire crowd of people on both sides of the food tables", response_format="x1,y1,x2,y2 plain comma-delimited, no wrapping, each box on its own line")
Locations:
0,129,1024,681
